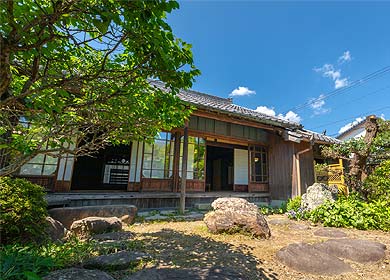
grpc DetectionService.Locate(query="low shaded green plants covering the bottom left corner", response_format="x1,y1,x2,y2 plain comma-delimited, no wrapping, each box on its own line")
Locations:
0,239,143,280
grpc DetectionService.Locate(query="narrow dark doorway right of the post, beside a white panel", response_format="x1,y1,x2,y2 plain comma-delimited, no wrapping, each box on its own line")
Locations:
206,146,234,191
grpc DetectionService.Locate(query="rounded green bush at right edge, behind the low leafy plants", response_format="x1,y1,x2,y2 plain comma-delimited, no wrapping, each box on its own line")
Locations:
363,160,390,201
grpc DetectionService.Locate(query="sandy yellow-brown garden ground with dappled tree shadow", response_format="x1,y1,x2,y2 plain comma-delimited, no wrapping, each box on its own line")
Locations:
130,215,390,280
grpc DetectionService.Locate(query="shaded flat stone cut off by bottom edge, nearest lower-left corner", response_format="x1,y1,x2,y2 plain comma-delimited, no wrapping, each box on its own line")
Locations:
43,268,115,280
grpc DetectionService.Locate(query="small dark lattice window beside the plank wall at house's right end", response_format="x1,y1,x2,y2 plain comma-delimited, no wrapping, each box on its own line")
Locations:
250,146,268,183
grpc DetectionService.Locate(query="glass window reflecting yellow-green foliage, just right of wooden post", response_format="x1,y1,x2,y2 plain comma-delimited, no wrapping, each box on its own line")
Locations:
179,136,206,180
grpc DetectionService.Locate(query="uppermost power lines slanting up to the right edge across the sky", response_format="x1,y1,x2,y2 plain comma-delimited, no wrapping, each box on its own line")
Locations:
284,66,390,114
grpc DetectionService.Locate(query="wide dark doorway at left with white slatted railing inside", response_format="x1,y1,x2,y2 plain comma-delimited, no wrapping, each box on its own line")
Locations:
72,145,131,190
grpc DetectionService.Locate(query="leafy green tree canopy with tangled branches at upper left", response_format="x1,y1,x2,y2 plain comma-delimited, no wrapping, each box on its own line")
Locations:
0,0,200,175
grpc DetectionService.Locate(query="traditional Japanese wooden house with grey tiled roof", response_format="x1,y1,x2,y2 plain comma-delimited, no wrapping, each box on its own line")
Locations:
19,82,338,206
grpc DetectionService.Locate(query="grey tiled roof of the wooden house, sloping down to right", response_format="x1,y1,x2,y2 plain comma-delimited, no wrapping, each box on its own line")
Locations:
151,81,341,144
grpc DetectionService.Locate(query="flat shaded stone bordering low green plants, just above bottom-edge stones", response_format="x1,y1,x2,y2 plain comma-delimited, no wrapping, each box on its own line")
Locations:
83,251,150,270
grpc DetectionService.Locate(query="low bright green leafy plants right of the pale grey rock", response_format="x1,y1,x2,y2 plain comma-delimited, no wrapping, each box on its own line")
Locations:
307,194,390,231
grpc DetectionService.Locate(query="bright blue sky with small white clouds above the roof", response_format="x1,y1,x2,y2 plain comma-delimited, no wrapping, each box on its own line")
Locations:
168,1,390,136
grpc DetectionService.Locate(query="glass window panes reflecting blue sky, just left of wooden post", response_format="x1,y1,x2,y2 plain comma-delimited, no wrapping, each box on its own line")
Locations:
142,132,175,179
